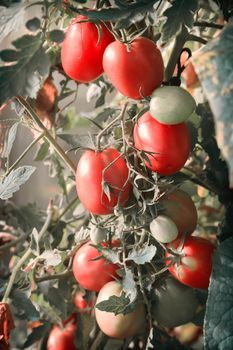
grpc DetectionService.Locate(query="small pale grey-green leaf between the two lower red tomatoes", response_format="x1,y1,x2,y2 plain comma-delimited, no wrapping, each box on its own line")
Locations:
126,244,157,265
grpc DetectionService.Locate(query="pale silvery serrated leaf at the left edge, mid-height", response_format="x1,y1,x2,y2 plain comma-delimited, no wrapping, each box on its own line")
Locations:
0,165,36,200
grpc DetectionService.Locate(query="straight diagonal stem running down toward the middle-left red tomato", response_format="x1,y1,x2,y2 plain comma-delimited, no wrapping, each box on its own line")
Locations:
17,96,76,174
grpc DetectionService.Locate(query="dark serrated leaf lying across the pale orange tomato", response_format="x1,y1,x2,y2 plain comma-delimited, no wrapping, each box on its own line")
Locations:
95,294,132,315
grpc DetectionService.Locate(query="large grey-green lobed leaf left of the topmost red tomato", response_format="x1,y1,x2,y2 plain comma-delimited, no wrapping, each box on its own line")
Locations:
0,33,49,104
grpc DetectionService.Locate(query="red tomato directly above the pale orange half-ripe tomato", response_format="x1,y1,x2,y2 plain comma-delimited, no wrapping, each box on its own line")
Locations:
73,241,119,292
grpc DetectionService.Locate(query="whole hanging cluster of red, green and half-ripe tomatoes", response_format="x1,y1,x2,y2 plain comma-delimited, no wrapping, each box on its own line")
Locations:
48,11,217,349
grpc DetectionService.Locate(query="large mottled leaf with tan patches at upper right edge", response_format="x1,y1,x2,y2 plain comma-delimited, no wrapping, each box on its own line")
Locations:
192,24,233,187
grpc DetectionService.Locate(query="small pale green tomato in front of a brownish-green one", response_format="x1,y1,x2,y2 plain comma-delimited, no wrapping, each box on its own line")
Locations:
150,215,179,243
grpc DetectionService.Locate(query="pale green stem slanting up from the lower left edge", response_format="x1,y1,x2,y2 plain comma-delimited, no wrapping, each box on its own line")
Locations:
2,204,53,303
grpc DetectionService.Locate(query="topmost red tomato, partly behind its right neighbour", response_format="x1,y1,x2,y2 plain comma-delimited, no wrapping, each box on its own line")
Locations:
61,16,114,83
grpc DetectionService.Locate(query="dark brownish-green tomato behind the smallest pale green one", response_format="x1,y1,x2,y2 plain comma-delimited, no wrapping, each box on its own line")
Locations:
159,189,197,236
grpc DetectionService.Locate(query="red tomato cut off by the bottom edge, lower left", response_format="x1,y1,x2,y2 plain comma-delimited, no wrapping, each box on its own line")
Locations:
47,317,78,350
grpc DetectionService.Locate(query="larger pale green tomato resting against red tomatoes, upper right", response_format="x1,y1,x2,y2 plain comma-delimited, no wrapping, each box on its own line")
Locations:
150,86,196,125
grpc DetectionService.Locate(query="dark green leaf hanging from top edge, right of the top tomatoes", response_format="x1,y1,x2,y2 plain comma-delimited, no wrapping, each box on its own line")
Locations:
161,0,198,42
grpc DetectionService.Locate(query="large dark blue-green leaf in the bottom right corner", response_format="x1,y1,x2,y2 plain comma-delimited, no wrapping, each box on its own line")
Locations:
204,237,233,350
